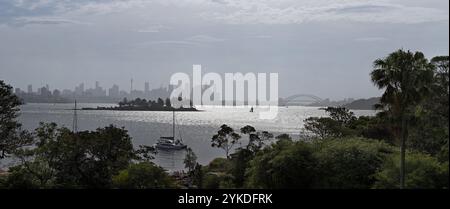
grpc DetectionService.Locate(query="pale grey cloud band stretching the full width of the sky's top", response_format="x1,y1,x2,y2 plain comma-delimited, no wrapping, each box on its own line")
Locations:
0,0,448,25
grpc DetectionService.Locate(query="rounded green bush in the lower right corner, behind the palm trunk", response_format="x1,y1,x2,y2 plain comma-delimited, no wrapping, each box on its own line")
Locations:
374,152,449,189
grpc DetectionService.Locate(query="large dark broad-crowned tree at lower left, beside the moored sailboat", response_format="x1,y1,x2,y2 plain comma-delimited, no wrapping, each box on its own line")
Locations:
11,123,138,188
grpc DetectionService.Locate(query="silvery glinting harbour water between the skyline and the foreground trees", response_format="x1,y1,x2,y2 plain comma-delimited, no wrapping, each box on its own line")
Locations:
10,103,374,171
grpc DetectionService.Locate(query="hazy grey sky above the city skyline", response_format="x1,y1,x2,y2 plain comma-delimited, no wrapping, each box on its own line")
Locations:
0,0,449,99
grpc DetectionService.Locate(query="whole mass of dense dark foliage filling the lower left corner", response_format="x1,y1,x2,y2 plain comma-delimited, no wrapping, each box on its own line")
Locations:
3,123,172,188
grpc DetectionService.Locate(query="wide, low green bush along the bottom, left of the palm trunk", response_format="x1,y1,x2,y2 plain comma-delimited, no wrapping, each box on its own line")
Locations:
246,138,393,189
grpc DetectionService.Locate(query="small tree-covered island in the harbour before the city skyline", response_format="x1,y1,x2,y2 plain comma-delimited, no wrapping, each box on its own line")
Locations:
82,98,199,111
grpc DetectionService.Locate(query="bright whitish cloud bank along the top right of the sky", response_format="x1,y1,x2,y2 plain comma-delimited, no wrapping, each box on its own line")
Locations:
203,0,448,24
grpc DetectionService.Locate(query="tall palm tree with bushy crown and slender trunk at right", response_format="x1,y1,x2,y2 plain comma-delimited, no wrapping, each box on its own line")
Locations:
371,49,433,188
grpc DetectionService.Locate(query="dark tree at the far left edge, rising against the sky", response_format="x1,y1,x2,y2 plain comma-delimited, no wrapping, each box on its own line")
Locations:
0,80,31,159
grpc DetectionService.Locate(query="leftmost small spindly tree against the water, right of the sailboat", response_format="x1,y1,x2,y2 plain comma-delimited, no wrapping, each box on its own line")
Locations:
211,124,241,158
